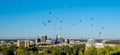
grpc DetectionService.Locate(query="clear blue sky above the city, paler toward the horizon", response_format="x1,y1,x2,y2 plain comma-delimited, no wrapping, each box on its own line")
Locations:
0,0,120,39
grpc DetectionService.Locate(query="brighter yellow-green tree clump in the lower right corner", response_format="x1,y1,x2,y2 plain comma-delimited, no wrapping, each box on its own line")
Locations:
84,46,120,55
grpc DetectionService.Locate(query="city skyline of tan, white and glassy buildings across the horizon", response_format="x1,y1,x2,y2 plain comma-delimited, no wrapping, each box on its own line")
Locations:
0,35,120,48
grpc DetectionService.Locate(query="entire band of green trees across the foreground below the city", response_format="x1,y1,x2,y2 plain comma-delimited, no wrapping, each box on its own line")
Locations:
0,45,120,55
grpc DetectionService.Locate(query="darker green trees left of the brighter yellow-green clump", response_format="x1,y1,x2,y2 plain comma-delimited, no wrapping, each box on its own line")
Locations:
0,45,85,55
